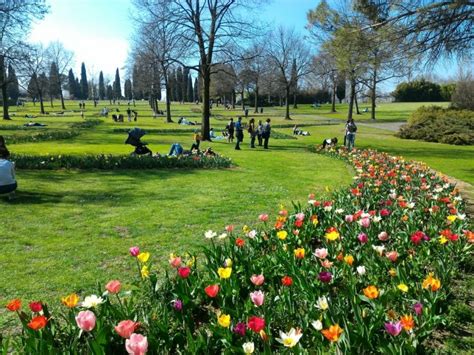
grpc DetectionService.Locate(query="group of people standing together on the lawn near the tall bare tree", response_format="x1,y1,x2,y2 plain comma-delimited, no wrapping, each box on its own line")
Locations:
225,117,272,150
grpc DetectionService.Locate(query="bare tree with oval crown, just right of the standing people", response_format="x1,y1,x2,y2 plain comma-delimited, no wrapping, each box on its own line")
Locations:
267,27,312,120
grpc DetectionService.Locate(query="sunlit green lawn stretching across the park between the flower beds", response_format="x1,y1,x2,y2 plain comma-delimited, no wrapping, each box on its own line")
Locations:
0,98,474,330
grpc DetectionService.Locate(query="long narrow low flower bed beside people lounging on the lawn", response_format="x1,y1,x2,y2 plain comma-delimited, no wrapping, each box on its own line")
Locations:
11,154,232,170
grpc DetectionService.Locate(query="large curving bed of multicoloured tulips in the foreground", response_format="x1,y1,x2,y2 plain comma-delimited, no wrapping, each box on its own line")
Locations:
4,149,474,354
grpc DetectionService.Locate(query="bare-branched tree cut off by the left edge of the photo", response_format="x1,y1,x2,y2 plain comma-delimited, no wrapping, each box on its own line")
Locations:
0,0,48,120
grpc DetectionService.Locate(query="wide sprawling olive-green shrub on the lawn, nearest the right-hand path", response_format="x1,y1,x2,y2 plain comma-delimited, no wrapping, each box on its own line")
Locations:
397,106,474,145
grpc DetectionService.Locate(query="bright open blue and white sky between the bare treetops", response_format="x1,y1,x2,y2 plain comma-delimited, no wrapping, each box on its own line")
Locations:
29,0,456,89
